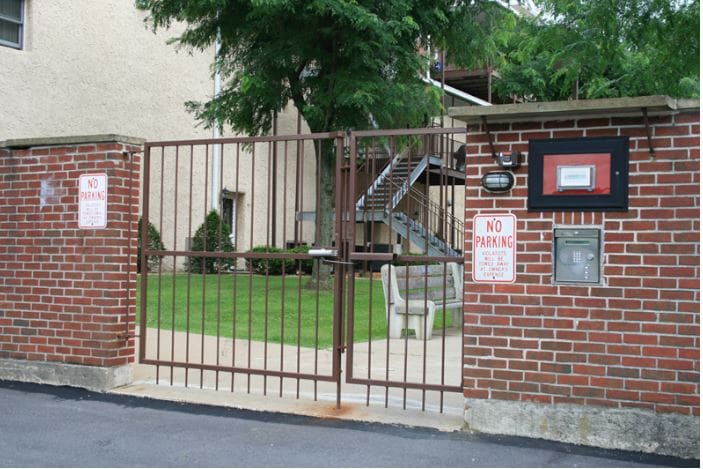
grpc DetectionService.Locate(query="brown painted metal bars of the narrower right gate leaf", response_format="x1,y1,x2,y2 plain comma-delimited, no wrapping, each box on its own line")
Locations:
339,128,465,411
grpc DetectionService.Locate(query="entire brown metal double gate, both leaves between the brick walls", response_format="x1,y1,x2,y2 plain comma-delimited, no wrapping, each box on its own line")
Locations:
139,129,465,411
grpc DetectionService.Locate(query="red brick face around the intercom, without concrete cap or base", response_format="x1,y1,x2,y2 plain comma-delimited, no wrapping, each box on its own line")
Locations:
464,109,700,415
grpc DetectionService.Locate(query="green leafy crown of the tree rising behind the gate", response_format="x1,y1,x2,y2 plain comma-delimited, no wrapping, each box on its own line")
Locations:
137,0,483,134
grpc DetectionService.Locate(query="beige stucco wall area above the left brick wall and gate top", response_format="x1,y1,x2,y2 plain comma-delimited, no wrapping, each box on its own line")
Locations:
0,0,213,141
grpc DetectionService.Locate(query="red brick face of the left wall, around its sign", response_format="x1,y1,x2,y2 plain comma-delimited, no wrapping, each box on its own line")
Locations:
0,143,141,366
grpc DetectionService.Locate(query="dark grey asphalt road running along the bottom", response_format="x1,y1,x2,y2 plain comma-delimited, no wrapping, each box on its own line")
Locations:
0,381,697,467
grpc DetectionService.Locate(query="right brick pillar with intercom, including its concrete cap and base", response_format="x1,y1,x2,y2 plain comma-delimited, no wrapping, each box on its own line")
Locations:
456,97,700,458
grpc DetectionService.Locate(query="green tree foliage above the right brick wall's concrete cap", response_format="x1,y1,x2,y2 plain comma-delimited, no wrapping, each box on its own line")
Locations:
496,0,700,101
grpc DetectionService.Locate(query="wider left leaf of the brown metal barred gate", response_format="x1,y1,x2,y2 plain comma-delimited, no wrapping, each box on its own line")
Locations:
139,132,346,403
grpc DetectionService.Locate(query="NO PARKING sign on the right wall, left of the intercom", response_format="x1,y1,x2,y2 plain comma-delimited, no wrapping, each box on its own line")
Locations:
473,213,517,283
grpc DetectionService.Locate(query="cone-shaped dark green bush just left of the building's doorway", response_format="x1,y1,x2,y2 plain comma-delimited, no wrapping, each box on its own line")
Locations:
186,210,234,274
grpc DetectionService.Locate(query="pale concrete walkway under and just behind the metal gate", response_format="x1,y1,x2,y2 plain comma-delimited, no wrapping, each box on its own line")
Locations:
115,329,464,431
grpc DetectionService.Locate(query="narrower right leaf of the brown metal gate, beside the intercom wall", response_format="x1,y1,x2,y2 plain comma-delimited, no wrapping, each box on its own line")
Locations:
340,128,465,412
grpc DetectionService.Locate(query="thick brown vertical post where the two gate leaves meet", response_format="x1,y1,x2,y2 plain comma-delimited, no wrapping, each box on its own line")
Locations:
333,136,349,409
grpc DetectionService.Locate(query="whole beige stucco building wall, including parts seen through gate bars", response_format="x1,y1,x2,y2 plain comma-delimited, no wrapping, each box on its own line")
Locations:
0,0,322,266
